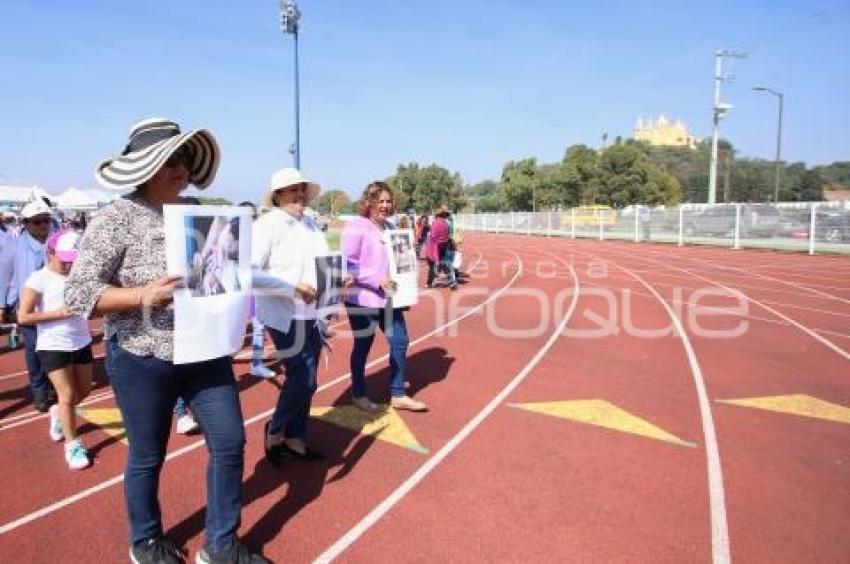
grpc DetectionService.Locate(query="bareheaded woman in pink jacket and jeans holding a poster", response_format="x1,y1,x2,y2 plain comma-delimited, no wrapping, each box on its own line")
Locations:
342,182,428,413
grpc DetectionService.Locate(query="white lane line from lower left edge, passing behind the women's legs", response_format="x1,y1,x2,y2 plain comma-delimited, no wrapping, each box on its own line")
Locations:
0,253,523,535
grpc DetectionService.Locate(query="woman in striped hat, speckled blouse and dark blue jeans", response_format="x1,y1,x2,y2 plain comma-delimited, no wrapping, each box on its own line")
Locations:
65,118,268,564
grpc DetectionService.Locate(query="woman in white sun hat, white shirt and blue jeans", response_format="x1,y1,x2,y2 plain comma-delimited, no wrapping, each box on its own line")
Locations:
251,168,328,465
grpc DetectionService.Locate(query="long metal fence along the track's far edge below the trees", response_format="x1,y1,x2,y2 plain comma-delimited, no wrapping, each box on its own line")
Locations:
455,201,850,254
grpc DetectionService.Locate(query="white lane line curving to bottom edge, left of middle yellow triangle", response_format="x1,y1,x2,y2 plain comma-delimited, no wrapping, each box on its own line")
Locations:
313,256,579,564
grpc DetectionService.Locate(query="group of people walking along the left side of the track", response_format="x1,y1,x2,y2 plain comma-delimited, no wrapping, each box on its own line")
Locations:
0,118,460,564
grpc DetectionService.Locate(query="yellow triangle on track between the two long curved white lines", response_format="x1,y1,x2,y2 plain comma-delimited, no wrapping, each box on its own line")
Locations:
508,400,695,447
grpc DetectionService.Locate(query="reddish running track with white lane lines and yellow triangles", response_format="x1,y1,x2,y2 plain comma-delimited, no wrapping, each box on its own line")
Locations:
0,234,850,563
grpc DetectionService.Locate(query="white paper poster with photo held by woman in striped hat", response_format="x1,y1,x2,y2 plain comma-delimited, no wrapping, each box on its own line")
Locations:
163,205,252,364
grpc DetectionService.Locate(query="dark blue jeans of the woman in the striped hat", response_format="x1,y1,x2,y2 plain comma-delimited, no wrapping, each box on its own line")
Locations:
110,345,245,552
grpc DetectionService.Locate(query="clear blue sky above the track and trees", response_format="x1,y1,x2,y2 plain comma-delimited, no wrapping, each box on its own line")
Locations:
0,0,850,200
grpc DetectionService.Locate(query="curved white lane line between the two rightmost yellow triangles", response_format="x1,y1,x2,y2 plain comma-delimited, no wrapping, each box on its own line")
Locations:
609,261,731,564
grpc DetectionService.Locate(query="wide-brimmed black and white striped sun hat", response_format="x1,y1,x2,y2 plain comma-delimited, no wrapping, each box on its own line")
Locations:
94,118,220,190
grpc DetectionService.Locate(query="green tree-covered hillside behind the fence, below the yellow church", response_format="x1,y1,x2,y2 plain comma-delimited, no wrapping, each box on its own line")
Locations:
464,139,832,212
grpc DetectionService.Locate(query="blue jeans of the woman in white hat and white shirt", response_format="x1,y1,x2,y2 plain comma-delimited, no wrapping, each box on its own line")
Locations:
266,319,322,439
